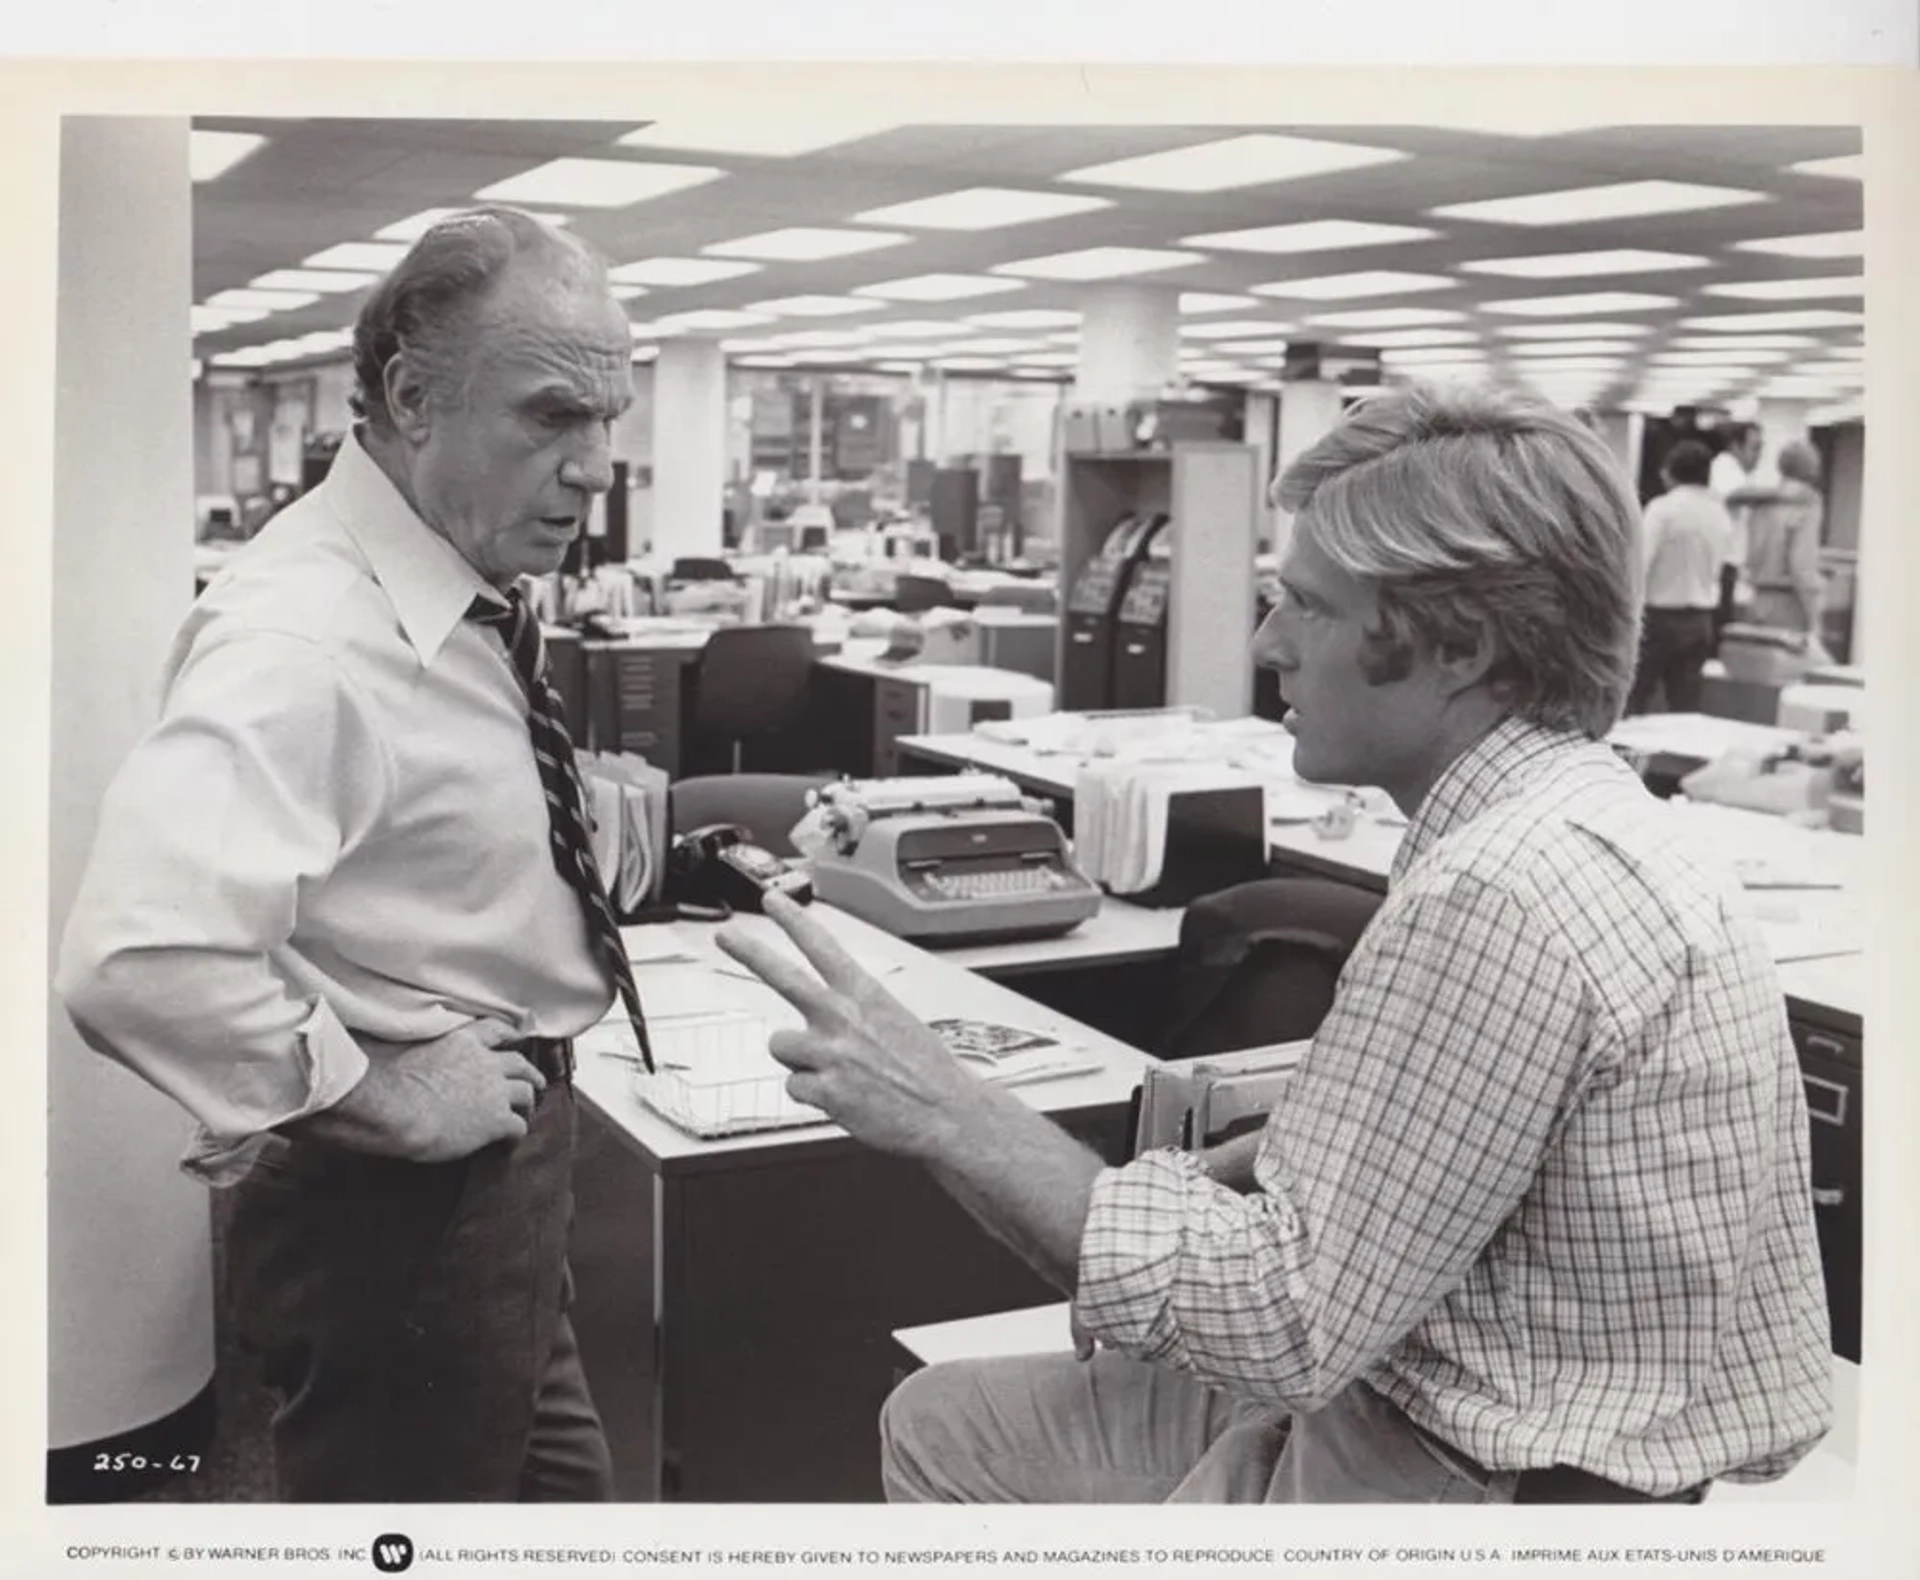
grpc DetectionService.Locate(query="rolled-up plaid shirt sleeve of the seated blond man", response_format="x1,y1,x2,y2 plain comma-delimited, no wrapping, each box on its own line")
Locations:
1075,877,1592,1409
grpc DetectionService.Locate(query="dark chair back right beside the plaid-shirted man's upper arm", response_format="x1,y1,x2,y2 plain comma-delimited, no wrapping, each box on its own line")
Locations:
1158,877,1382,1060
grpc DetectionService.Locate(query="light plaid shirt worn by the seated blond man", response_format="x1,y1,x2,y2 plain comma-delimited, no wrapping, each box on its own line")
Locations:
1075,720,1832,1494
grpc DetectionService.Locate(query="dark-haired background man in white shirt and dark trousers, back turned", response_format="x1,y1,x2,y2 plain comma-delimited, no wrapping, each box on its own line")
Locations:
1626,440,1734,712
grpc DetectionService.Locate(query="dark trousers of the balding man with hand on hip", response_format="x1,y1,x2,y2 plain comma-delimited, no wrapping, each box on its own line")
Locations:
227,1081,612,1503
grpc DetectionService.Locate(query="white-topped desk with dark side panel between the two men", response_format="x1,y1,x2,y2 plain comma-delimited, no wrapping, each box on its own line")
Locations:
576,906,1148,1503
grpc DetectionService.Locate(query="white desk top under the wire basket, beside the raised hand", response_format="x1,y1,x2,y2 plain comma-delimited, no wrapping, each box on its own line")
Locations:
576,904,1150,1175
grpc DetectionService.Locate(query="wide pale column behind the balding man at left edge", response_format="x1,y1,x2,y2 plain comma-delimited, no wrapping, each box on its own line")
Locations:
46,115,213,1448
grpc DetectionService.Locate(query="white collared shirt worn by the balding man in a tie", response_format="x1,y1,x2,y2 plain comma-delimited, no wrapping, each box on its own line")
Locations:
56,436,611,1183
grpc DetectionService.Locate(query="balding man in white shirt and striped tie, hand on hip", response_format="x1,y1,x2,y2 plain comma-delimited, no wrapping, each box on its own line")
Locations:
58,209,637,1501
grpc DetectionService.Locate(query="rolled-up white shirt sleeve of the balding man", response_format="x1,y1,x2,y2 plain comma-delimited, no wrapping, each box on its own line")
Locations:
54,634,392,1183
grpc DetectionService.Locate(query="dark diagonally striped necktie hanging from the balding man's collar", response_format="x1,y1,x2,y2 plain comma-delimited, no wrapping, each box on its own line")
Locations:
467,587,653,1071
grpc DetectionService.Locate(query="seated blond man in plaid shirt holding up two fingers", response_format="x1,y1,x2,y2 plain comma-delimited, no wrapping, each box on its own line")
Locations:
728,392,1830,1503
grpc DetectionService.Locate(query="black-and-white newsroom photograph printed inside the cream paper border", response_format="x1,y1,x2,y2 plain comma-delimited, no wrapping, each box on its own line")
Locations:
18,55,1907,1572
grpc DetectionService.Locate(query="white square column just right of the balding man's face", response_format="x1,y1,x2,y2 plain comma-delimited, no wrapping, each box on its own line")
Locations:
653,338,726,563
